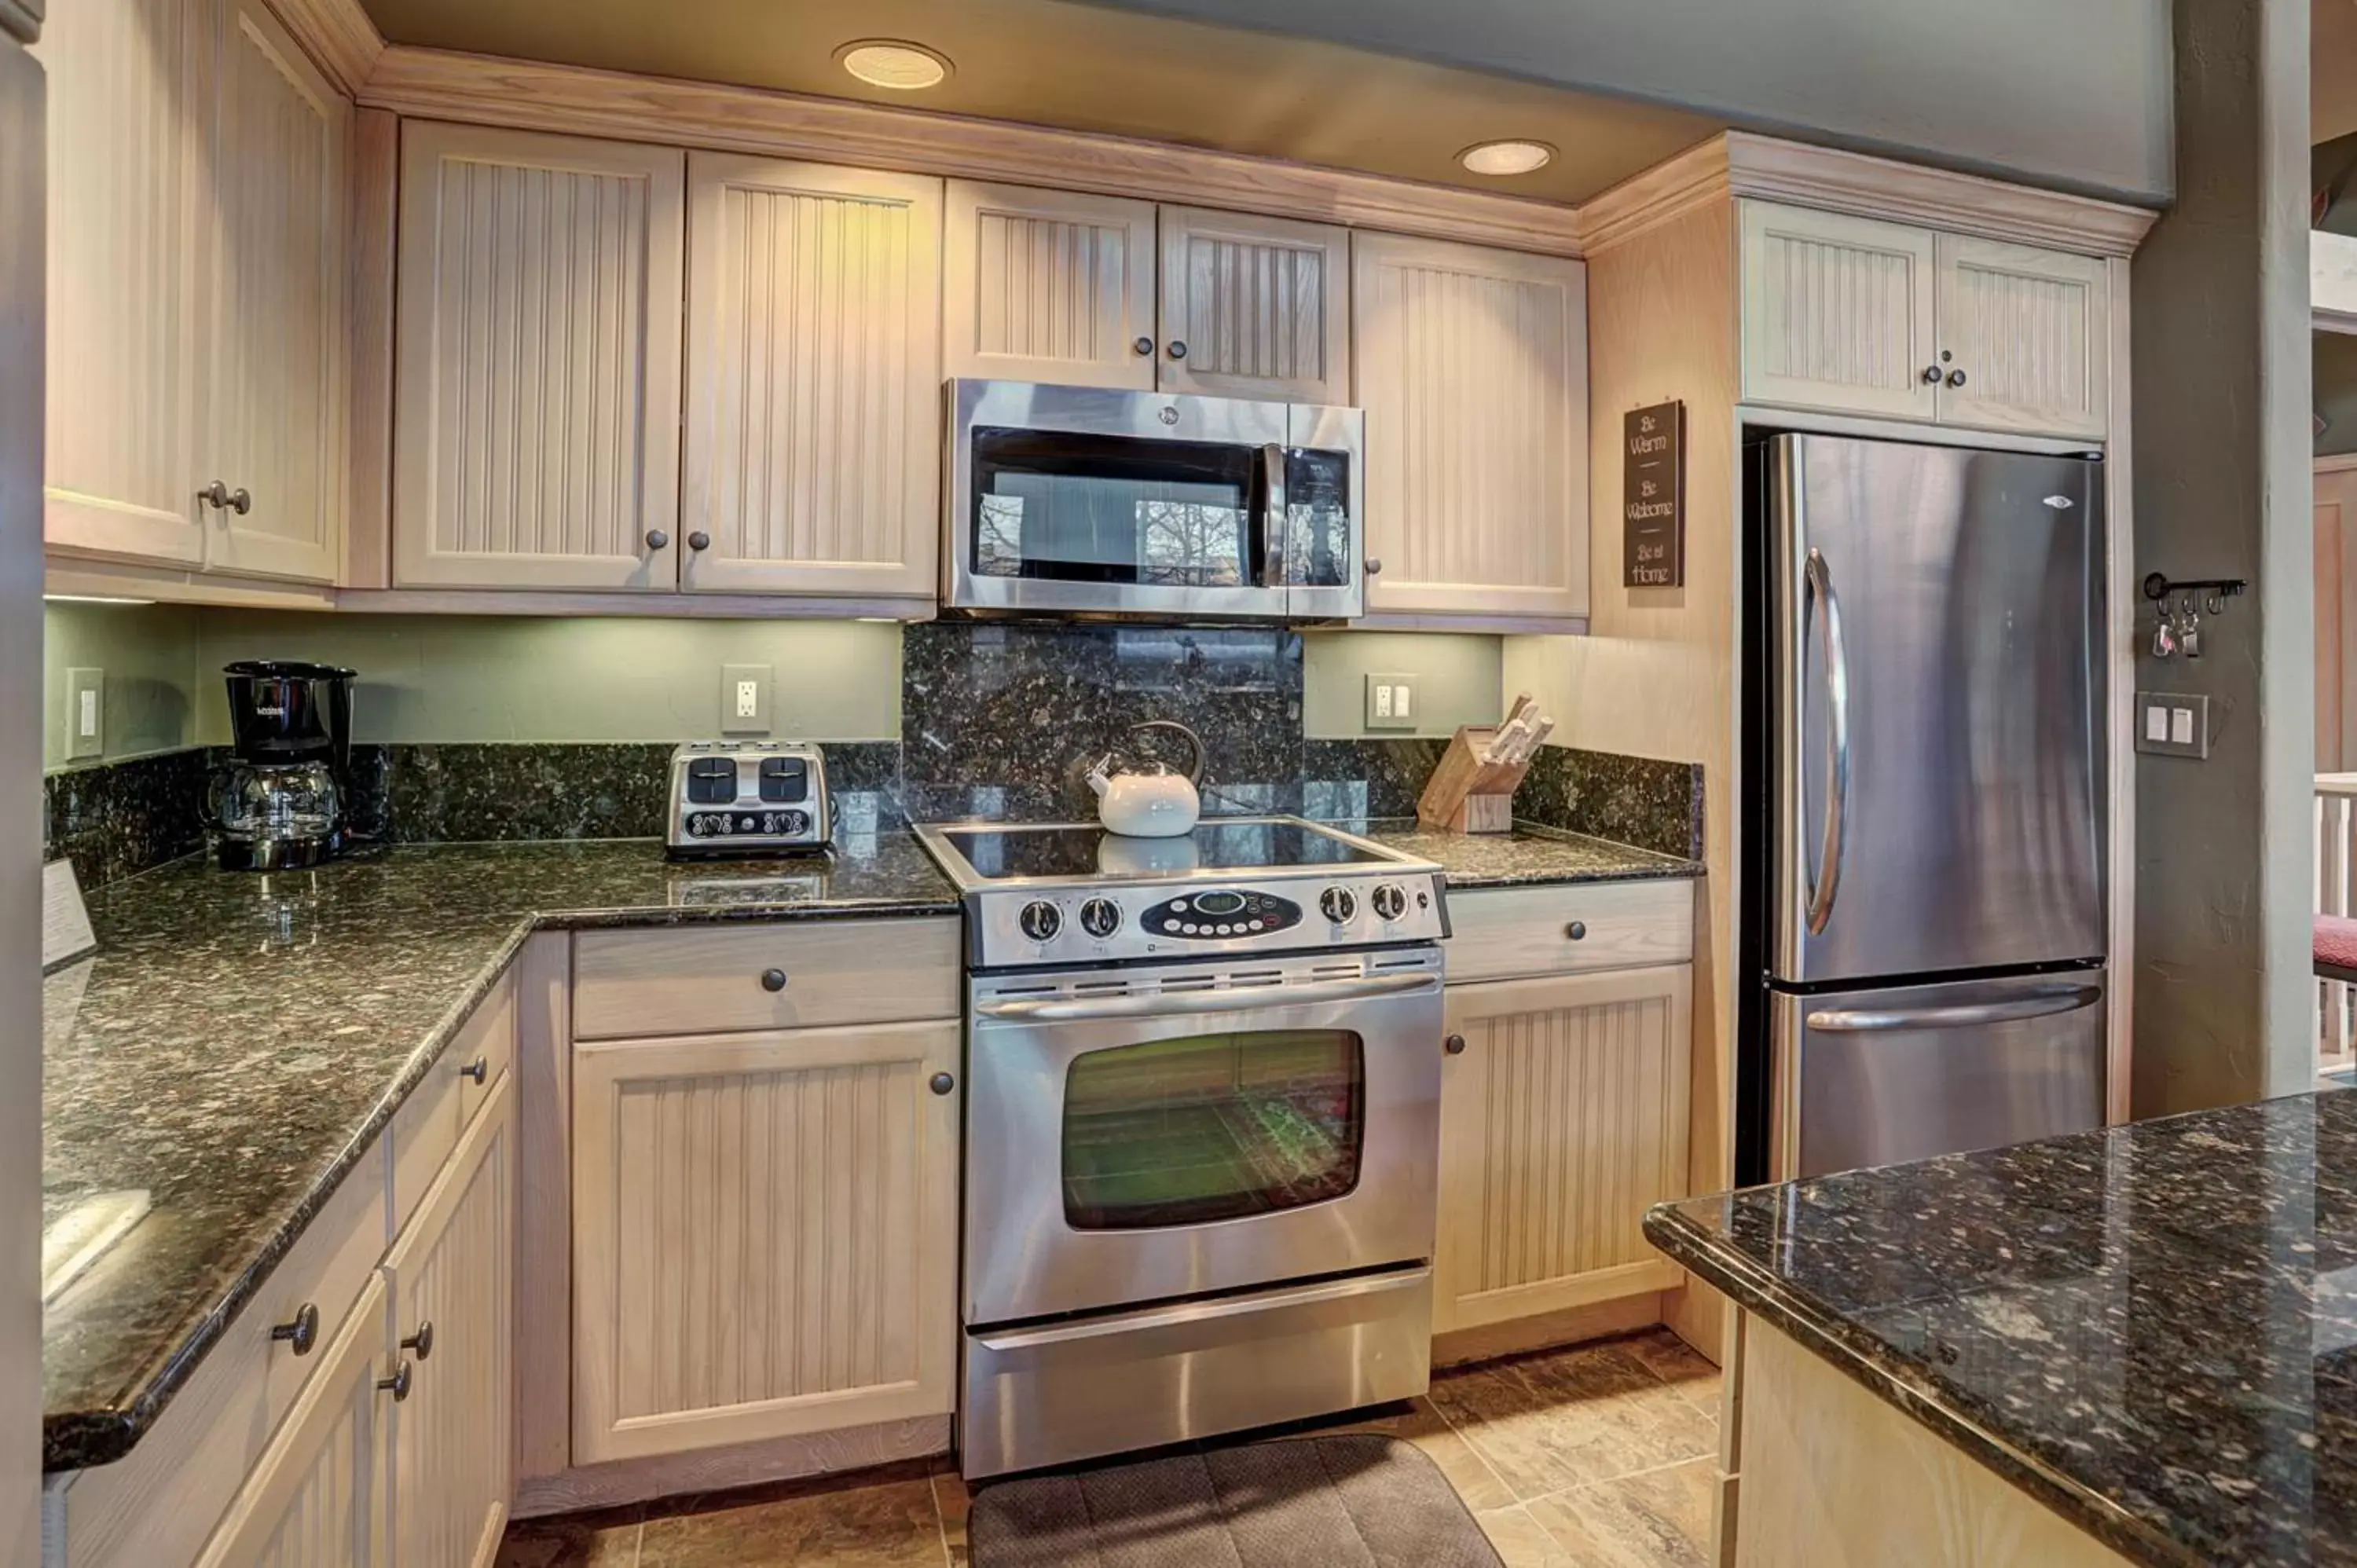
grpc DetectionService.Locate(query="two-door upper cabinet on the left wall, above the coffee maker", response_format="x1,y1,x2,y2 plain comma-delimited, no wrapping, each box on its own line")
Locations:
42,0,349,582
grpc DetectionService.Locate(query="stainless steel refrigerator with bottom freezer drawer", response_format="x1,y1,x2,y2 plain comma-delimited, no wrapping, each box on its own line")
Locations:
1737,434,2107,1179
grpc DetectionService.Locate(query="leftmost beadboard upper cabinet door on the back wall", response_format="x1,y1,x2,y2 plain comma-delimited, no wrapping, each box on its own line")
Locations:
394,120,686,589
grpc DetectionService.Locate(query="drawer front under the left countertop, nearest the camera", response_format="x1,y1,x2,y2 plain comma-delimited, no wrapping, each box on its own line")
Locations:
52,1141,387,1568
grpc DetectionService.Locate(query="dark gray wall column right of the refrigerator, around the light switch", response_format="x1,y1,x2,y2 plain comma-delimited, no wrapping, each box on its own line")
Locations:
2133,0,2315,1116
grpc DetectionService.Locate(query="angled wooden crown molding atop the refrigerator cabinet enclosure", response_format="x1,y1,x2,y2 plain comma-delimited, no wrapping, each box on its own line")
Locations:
1579,130,2159,257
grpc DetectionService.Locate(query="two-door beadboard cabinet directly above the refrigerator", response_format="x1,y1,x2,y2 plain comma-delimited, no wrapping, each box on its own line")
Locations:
1742,200,2110,438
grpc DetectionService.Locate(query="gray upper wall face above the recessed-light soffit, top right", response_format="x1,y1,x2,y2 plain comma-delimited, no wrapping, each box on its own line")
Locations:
1101,0,2178,203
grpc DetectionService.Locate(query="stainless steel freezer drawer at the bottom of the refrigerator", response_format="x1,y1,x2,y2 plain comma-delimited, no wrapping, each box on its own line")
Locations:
1768,969,2105,1181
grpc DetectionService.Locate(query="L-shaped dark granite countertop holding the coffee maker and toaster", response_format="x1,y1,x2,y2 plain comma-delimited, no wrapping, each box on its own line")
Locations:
42,833,959,1469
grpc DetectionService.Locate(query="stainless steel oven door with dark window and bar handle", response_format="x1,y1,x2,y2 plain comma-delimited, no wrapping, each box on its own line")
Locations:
964,951,1440,1328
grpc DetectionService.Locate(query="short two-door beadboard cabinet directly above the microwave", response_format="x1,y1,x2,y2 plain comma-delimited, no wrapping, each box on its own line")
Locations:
943,179,1351,403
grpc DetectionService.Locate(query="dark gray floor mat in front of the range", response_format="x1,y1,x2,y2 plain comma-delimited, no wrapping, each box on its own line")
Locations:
966,1434,1504,1568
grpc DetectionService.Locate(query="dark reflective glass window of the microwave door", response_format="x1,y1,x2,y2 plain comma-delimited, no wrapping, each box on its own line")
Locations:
966,427,1266,587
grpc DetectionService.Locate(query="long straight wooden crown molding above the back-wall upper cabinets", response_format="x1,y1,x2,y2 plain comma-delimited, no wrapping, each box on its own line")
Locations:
354,46,1579,257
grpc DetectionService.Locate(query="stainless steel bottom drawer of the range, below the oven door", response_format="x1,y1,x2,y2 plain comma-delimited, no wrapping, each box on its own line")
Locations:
959,1266,1433,1481
